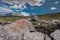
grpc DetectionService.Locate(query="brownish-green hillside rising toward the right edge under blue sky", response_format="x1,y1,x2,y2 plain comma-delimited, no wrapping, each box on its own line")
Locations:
39,13,60,20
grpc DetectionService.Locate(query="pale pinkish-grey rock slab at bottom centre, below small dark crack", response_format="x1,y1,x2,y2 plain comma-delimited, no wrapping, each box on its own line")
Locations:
24,32,51,40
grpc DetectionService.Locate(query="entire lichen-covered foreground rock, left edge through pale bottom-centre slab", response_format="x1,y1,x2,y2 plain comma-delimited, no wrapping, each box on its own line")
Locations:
0,19,50,40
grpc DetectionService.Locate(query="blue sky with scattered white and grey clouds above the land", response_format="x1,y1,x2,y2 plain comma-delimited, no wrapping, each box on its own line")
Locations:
0,0,60,15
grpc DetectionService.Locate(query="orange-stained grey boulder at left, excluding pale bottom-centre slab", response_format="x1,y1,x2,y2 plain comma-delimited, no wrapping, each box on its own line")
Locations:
0,19,35,40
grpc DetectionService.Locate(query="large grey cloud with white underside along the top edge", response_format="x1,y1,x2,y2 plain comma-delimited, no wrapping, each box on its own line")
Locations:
3,0,45,6
